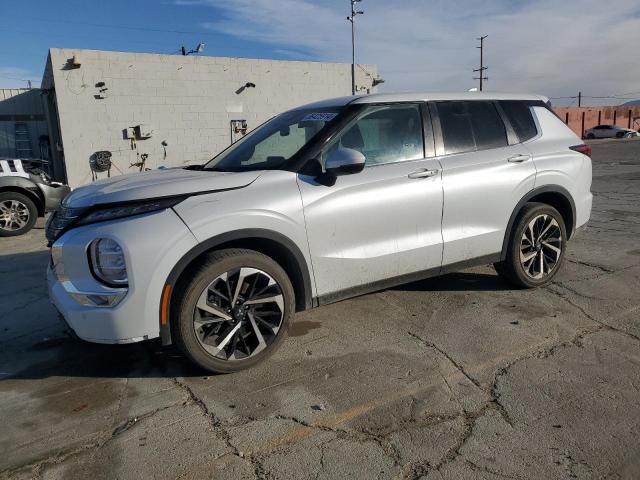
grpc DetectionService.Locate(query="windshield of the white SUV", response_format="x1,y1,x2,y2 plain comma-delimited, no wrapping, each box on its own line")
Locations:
203,107,341,172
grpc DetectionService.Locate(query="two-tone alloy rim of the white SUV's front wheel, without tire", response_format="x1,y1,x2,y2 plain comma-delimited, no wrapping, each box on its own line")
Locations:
193,267,285,361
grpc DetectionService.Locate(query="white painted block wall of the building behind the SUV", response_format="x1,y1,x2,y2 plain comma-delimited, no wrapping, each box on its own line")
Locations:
43,49,377,187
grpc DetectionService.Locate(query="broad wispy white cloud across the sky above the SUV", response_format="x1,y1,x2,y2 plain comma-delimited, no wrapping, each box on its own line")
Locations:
191,0,640,102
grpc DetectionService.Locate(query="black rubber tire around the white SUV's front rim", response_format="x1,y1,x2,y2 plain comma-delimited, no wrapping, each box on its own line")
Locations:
171,248,295,373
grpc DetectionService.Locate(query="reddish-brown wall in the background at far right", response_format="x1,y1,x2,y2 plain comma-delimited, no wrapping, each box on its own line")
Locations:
554,106,640,137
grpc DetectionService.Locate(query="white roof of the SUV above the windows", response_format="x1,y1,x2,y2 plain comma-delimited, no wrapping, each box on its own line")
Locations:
296,92,549,110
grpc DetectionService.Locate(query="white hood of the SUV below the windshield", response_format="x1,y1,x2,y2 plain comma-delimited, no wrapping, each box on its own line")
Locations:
64,168,261,208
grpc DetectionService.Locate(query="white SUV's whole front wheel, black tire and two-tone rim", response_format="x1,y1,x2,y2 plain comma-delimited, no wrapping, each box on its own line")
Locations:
172,249,295,373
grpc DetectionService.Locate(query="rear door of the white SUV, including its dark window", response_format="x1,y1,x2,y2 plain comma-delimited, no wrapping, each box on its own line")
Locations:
431,100,536,265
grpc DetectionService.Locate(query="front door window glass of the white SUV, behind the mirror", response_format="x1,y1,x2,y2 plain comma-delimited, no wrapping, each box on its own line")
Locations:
322,104,424,167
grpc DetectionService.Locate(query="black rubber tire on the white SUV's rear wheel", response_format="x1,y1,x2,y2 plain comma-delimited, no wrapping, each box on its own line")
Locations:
493,203,567,288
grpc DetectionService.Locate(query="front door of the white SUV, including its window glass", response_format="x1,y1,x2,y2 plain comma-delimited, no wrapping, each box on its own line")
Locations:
298,104,442,296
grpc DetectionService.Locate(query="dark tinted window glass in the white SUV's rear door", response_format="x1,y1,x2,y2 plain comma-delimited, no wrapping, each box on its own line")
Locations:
436,101,508,154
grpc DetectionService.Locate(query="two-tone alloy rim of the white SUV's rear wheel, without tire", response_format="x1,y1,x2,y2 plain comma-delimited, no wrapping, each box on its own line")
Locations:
520,214,562,280
